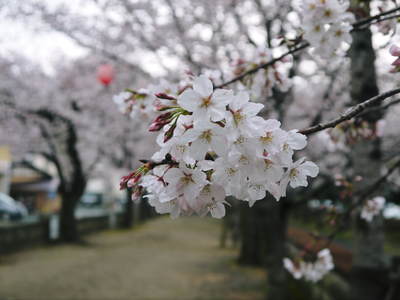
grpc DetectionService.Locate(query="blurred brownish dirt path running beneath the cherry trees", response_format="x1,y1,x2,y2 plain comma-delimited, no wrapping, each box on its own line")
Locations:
0,218,264,300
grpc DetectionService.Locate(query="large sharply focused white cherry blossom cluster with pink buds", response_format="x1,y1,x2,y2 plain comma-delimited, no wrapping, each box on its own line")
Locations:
121,75,318,218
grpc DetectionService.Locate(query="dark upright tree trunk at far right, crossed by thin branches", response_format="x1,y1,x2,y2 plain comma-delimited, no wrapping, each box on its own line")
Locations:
350,1,387,300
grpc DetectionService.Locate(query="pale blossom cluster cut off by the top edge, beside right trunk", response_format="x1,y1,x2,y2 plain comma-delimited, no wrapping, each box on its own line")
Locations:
301,0,354,58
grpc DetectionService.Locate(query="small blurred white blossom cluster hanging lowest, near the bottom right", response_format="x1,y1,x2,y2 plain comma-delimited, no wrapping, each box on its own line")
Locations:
283,248,334,282
